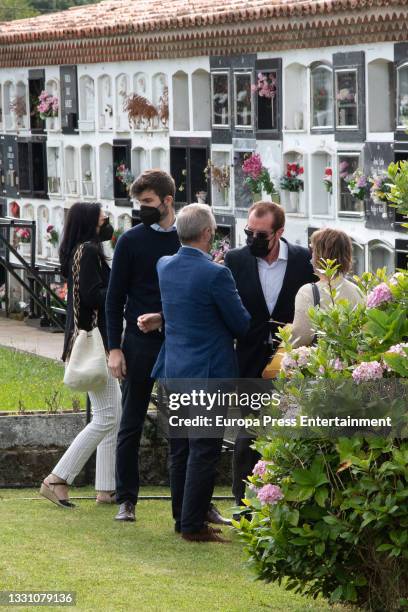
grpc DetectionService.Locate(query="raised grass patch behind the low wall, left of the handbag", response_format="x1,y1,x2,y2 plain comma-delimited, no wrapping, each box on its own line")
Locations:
0,346,85,412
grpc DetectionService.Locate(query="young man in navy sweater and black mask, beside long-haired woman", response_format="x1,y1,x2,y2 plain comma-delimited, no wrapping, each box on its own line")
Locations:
106,170,180,521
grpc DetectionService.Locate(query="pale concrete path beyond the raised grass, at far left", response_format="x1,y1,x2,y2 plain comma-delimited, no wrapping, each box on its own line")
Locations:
0,317,64,360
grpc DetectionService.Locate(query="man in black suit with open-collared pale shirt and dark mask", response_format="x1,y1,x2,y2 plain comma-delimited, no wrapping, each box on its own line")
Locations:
225,202,317,505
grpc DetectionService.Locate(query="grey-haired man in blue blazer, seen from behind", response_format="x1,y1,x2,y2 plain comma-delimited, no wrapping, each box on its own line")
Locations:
152,204,250,542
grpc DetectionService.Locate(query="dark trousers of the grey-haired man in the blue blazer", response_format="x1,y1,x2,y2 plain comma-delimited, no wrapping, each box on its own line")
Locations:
170,438,222,533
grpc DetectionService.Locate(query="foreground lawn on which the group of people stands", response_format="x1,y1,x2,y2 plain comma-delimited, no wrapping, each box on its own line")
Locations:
0,487,344,612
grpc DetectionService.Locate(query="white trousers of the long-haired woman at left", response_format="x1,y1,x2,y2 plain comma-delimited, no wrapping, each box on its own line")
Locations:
52,371,122,491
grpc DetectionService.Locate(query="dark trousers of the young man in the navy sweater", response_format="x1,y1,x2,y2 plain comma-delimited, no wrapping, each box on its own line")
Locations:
116,329,162,504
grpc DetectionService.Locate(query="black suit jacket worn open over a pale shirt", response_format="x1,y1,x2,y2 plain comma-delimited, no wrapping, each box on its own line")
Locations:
225,238,318,378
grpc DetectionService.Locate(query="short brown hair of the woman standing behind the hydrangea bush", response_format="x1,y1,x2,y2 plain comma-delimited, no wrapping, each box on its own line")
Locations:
310,227,353,274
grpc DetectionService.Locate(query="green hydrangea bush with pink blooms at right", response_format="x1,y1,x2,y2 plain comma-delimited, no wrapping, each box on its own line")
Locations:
235,261,408,611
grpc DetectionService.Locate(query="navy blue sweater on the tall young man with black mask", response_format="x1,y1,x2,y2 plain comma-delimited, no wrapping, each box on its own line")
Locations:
106,223,180,350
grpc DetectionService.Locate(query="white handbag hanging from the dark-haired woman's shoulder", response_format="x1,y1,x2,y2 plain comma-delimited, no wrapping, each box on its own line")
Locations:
64,244,108,392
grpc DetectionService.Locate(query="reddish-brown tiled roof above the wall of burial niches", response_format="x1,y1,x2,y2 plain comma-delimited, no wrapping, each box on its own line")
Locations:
0,0,408,66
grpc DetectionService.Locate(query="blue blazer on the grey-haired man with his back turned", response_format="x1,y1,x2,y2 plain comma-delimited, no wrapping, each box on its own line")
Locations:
152,247,251,379
